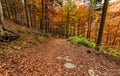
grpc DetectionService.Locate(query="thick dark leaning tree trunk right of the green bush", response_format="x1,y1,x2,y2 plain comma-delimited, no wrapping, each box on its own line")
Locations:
96,0,109,50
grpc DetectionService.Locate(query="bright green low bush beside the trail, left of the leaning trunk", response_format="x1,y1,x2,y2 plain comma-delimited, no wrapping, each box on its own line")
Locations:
68,35,95,48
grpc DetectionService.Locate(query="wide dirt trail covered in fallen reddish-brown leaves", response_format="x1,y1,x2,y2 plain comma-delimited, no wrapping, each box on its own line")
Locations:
0,39,120,76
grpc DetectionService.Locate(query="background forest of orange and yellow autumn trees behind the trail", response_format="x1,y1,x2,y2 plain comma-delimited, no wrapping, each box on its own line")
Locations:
2,0,120,48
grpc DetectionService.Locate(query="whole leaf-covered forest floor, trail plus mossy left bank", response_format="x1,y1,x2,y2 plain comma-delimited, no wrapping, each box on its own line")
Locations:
0,21,120,76
